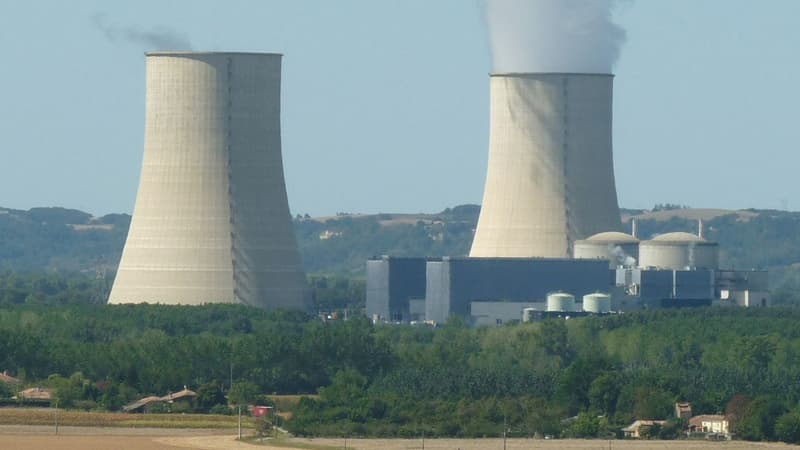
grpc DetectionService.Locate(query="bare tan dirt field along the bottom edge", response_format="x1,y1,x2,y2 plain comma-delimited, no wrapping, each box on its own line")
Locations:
0,426,797,450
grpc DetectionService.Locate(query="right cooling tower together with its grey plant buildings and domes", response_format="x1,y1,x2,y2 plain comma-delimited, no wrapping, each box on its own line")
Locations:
366,73,769,325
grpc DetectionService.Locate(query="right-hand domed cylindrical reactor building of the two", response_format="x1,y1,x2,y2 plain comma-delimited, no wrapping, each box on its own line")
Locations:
639,232,719,270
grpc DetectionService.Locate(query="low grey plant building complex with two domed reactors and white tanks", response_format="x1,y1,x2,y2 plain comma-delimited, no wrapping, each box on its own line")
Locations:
367,227,769,326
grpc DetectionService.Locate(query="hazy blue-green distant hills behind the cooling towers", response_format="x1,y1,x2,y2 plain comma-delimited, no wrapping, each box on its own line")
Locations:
0,205,800,298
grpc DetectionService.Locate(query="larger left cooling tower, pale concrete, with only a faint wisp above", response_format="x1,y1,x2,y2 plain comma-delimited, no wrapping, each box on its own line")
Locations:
108,52,308,309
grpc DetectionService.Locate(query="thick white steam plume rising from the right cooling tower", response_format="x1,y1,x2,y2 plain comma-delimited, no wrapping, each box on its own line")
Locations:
484,0,625,73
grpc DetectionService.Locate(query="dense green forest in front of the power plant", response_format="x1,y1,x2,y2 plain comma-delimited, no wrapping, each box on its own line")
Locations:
0,305,800,442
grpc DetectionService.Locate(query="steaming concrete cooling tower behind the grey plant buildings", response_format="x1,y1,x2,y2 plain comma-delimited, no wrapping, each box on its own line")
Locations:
470,73,621,258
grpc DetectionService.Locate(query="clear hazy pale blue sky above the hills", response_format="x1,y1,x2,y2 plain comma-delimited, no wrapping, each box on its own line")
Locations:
0,0,800,215
